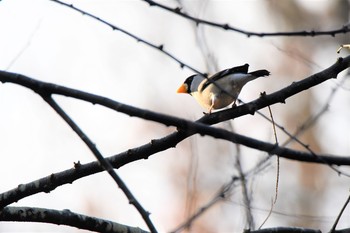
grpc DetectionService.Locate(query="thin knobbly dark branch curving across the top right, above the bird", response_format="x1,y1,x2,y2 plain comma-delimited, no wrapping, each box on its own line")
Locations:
142,0,350,37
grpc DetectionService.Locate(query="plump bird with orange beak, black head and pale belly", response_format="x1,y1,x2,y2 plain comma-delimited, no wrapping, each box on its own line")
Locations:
177,64,270,114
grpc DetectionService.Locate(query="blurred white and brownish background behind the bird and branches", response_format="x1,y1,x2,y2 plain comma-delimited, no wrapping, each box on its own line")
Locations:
0,0,350,233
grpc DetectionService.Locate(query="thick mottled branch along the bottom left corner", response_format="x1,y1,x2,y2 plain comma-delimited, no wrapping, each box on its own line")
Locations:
0,207,148,233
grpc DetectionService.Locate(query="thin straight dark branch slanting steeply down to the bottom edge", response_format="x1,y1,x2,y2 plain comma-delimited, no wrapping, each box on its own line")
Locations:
41,94,157,233
